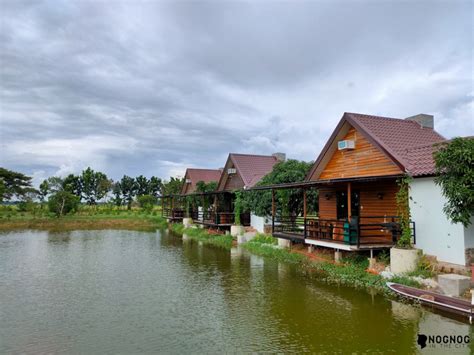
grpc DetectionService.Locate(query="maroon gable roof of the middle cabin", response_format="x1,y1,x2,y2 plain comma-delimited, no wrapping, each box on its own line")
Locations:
219,153,279,190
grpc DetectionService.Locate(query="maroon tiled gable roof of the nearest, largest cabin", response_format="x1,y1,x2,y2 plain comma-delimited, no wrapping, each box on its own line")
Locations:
307,112,445,180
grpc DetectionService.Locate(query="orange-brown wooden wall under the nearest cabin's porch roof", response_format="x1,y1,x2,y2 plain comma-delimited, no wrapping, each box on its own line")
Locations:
319,180,398,223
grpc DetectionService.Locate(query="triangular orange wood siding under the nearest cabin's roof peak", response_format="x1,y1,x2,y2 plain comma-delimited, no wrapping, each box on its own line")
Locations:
320,127,402,179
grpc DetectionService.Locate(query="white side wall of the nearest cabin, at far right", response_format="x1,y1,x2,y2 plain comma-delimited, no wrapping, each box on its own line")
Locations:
410,177,466,265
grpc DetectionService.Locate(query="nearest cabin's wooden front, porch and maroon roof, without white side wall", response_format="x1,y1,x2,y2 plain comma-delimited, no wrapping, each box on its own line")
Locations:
274,113,444,250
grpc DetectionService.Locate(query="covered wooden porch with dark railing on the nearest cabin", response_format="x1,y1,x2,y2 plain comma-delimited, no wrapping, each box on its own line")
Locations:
252,177,416,251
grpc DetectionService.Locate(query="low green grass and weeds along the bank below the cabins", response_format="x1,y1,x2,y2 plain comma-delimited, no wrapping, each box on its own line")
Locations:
170,224,421,293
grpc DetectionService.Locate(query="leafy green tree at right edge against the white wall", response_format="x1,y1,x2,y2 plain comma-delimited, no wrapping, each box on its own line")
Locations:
434,137,474,227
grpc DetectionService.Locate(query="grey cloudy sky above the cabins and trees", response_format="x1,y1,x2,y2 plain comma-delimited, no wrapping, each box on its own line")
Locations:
0,0,474,182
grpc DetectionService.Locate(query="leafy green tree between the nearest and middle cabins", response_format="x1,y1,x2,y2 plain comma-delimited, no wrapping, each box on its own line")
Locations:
242,159,318,217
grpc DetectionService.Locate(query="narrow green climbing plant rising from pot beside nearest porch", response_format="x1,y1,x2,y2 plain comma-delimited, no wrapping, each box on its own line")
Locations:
395,175,412,249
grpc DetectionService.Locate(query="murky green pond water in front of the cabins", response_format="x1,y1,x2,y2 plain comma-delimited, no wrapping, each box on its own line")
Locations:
0,230,472,354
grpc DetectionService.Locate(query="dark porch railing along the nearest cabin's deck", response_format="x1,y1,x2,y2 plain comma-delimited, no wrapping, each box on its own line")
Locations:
272,216,416,247
